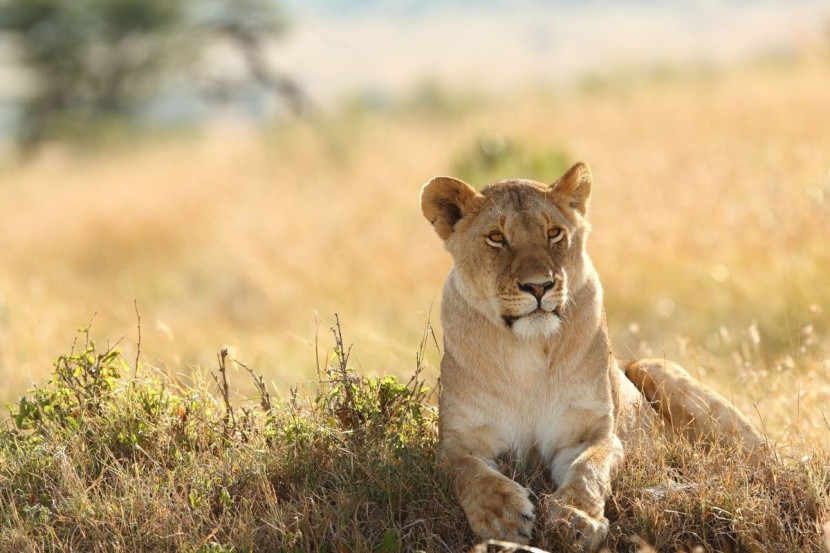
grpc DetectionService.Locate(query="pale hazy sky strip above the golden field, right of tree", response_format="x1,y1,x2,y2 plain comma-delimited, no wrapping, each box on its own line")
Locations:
273,0,830,103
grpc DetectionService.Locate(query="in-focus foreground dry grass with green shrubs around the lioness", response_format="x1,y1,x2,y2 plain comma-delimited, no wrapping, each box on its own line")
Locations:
0,326,830,553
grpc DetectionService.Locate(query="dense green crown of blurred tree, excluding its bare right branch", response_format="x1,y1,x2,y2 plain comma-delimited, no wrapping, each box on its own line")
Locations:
0,0,188,148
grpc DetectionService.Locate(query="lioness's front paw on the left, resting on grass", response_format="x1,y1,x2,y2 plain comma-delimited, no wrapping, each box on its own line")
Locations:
461,475,536,543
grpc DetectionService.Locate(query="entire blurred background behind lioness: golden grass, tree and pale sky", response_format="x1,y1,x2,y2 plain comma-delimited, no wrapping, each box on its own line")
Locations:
0,0,830,444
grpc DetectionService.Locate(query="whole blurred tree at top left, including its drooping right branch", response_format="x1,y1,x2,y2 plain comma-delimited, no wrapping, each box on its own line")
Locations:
0,0,305,149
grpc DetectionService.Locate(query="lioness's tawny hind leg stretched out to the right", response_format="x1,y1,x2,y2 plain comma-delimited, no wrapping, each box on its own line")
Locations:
621,359,768,464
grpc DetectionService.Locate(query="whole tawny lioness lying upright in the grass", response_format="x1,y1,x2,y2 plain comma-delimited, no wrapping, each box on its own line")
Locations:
421,163,765,551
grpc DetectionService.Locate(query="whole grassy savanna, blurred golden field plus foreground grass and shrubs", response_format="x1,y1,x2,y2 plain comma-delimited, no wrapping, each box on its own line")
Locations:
0,50,830,552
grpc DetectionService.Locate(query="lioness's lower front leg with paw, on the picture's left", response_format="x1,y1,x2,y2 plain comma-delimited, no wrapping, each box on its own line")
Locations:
442,442,536,543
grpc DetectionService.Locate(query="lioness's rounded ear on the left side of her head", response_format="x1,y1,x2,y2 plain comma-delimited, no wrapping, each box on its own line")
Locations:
421,177,481,240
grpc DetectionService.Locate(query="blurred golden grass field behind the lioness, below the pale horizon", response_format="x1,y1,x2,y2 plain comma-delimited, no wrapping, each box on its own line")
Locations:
0,51,830,455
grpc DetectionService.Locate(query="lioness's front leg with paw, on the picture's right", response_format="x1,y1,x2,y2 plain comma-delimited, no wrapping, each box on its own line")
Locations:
540,422,622,552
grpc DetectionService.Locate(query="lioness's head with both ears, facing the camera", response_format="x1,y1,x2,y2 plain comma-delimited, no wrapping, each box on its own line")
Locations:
421,163,591,338
